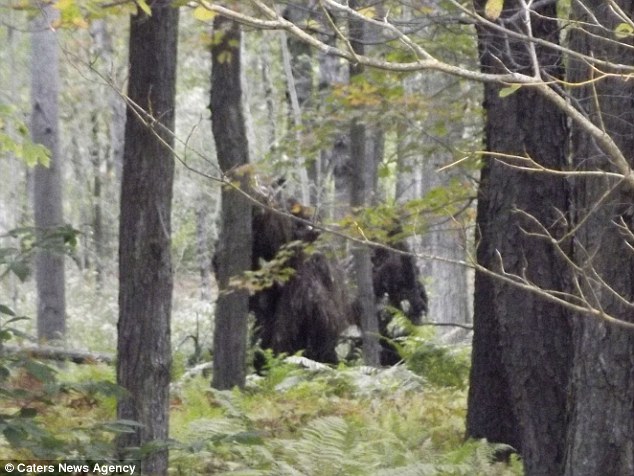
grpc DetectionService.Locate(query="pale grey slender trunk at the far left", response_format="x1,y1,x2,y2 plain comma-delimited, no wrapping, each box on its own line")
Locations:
31,0,66,342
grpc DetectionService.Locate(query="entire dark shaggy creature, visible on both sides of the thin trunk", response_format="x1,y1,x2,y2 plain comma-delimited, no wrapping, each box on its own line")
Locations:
249,186,427,371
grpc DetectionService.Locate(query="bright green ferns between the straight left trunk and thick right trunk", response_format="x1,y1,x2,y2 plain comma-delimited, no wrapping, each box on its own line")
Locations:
170,357,522,476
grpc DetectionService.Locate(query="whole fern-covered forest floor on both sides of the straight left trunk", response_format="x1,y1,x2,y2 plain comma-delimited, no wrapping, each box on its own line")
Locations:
0,273,522,476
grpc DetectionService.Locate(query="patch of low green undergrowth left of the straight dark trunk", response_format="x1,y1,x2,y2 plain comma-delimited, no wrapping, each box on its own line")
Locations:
0,356,127,460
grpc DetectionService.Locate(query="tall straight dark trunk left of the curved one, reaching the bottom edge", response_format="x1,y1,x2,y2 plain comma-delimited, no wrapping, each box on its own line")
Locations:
117,0,178,475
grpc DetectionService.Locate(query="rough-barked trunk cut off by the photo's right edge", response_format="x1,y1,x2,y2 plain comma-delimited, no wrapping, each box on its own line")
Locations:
561,0,634,476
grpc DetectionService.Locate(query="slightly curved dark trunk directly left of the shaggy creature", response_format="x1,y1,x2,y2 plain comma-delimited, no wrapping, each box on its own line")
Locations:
211,17,252,389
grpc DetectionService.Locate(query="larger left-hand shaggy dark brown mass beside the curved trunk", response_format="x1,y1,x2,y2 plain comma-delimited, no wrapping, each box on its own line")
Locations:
249,193,351,371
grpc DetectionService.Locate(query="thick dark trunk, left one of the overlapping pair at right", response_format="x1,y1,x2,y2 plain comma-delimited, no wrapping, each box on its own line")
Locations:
467,1,572,475
